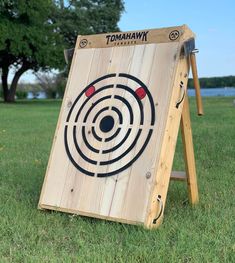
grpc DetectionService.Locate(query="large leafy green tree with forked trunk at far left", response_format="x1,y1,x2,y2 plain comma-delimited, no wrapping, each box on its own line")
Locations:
0,0,63,102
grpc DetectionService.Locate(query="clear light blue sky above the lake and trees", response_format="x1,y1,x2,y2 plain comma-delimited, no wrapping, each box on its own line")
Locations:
21,0,235,81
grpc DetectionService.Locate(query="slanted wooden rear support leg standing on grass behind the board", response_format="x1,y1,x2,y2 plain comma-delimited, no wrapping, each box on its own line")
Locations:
181,95,199,204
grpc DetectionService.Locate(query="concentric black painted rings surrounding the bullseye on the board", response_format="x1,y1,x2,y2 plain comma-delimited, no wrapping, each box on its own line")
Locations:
64,73,155,177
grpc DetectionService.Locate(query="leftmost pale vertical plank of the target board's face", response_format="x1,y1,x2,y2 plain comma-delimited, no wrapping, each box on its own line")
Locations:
38,40,93,208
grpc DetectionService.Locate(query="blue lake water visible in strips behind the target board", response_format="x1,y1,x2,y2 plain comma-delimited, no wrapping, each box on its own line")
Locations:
28,88,235,99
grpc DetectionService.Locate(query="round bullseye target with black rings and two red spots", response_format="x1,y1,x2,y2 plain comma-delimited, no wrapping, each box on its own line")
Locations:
64,73,156,177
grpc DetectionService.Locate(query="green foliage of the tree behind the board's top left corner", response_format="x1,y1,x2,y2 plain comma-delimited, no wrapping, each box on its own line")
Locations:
53,0,124,48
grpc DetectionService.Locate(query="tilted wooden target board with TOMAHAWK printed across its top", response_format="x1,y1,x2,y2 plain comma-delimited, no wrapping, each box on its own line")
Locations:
39,26,197,227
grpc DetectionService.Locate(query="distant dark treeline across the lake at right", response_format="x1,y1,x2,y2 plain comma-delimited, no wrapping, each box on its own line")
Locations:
188,76,235,89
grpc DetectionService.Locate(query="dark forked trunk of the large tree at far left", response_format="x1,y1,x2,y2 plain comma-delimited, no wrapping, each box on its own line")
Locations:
2,64,29,103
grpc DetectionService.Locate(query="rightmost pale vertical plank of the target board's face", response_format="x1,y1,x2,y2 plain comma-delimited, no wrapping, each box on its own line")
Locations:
116,43,179,224
